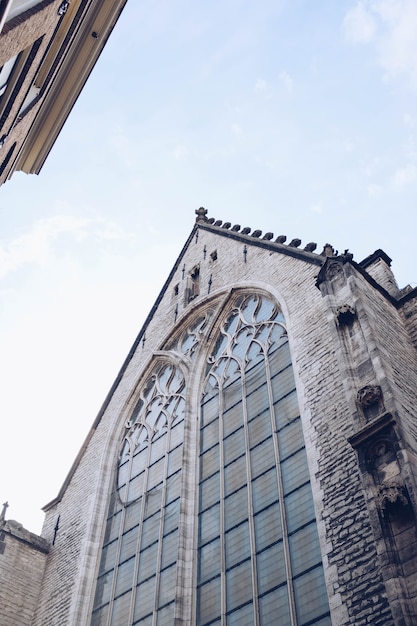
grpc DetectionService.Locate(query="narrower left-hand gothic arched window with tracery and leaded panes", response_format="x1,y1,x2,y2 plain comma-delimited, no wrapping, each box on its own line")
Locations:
91,364,185,626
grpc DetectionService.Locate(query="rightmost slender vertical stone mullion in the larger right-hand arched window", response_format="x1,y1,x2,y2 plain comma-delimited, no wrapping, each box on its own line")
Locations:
265,336,297,626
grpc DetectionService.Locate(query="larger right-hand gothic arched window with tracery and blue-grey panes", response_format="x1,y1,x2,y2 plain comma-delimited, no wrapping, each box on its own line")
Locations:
196,296,331,626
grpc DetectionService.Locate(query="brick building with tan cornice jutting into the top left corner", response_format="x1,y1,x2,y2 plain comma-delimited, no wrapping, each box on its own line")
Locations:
0,0,126,184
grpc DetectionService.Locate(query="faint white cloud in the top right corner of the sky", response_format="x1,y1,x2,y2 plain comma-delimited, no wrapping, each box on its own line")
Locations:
343,0,417,89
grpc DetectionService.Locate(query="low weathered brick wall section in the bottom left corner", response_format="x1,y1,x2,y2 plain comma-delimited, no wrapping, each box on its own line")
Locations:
0,520,49,626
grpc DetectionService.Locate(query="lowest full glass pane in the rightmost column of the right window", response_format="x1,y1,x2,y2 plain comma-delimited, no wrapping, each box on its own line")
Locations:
294,566,329,626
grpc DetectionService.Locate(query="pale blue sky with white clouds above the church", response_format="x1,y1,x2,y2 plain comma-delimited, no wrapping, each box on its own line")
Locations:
0,0,417,533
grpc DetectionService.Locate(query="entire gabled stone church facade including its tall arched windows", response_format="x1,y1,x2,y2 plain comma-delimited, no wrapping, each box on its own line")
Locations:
0,209,417,626
